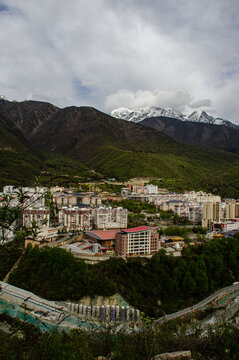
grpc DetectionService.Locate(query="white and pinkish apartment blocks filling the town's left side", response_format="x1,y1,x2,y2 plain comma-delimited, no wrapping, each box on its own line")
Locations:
0,186,128,239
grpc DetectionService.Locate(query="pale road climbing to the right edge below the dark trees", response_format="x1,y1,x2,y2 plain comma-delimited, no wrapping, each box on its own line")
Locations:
158,283,239,322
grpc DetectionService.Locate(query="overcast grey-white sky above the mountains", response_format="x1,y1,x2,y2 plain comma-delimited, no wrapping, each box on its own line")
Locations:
0,0,239,123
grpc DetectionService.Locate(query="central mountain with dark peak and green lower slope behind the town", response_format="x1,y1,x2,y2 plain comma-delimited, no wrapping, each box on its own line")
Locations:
32,107,239,193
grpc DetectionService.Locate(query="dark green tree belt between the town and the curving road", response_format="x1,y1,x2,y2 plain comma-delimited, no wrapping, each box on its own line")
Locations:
6,235,239,316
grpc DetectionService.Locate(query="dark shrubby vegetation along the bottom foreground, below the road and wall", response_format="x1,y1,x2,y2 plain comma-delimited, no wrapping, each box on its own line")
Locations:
0,314,239,360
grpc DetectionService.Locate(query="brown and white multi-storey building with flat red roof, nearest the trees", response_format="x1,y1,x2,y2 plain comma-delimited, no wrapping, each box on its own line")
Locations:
115,226,159,256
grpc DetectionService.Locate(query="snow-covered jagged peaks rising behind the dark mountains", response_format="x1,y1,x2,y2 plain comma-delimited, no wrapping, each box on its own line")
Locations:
111,106,239,129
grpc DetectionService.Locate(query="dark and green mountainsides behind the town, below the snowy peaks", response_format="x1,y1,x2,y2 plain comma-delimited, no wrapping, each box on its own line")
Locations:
0,99,239,197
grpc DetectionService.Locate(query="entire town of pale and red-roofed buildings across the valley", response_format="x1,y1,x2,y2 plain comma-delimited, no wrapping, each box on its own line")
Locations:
0,184,239,257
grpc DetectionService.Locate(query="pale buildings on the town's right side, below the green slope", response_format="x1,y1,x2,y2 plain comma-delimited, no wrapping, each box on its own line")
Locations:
121,185,239,232
